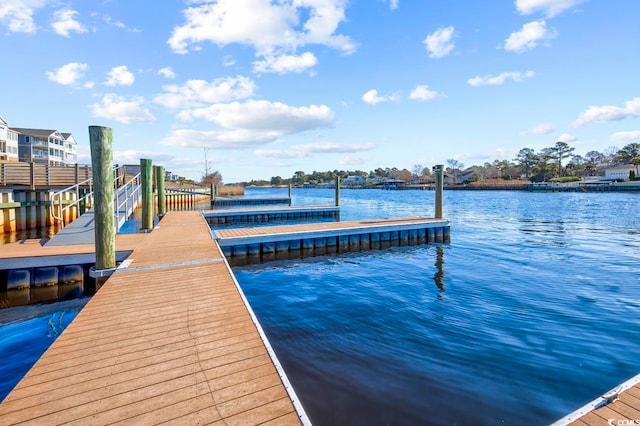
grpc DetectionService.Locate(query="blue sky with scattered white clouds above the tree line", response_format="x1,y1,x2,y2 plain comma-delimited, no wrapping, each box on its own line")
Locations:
0,0,640,183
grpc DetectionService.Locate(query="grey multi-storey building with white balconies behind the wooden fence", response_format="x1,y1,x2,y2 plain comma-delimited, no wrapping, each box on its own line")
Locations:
13,127,78,166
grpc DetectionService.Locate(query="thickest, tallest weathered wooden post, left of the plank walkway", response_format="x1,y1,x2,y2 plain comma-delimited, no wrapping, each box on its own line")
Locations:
89,126,116,290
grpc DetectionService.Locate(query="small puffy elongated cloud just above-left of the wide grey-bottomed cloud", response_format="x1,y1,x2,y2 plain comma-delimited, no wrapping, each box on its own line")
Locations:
153,76,256,108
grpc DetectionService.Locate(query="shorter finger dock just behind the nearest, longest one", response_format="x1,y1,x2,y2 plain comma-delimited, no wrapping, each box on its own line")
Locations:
202,206,340,226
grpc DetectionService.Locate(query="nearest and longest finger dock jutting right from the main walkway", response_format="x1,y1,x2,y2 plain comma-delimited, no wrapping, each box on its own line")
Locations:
212,217,450,261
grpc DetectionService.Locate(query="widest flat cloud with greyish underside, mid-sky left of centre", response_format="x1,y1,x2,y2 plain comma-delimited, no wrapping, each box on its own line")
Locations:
178,100,334,136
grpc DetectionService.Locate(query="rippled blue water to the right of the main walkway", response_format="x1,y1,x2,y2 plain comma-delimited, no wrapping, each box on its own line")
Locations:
234,190,640,425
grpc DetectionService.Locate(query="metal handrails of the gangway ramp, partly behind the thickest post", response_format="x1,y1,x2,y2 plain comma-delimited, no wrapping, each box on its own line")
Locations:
50,165,142,231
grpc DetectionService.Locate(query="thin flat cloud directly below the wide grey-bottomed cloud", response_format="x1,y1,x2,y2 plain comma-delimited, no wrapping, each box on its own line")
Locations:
160,129,278,149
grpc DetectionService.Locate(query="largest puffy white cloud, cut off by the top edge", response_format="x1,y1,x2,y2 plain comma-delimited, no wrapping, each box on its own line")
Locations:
167,0,356,72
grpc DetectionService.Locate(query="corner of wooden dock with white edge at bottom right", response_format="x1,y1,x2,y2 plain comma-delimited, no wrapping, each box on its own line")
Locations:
552,374,640,426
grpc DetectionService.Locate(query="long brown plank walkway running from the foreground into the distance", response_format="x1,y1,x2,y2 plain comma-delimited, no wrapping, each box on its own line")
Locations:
0,212,308,425
